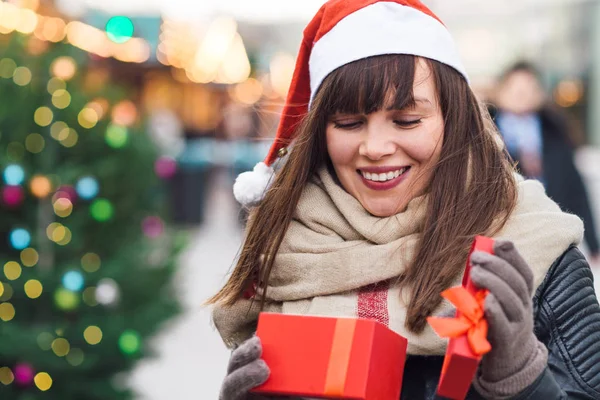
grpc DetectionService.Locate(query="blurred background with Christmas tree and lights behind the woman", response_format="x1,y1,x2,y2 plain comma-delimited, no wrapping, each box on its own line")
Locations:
0,0,600,400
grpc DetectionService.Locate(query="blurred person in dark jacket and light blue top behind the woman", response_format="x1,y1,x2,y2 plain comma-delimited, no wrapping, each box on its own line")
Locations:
490,61,600,265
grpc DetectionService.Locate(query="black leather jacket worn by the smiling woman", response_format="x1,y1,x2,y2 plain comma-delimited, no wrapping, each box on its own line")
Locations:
402,247,600,400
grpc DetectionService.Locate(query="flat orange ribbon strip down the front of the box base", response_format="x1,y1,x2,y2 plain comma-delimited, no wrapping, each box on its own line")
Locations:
324,318,356,398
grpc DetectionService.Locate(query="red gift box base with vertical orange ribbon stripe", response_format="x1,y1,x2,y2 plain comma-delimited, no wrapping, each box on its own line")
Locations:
253,313,407,400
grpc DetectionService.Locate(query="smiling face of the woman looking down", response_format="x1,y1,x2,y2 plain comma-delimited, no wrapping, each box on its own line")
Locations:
326,59,444,217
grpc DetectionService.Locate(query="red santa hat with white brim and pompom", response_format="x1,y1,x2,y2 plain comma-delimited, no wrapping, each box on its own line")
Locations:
233,0,467,206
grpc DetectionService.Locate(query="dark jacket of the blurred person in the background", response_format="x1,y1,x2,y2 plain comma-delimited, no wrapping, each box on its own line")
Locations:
489,106,600,253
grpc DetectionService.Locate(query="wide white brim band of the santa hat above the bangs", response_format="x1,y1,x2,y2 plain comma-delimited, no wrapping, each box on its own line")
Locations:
309,1,468,102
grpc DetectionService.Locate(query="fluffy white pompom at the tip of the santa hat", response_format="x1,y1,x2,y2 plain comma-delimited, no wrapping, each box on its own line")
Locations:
233,162,275,207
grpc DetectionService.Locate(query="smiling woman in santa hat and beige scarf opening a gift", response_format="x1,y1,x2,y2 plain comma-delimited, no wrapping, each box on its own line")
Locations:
210,0,600,400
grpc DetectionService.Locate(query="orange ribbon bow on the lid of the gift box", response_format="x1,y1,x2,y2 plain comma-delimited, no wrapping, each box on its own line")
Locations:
427,286,492,356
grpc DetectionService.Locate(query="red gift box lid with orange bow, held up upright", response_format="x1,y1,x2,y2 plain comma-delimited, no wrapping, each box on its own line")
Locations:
428,236,494,400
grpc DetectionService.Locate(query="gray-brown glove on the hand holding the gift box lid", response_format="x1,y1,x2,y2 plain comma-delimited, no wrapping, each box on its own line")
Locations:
471,241,548,399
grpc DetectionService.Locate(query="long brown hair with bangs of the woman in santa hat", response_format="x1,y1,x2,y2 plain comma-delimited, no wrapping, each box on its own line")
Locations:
208,55,516,333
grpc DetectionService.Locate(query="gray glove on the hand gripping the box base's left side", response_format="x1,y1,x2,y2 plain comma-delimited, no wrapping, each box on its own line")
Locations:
219,336,270,400
